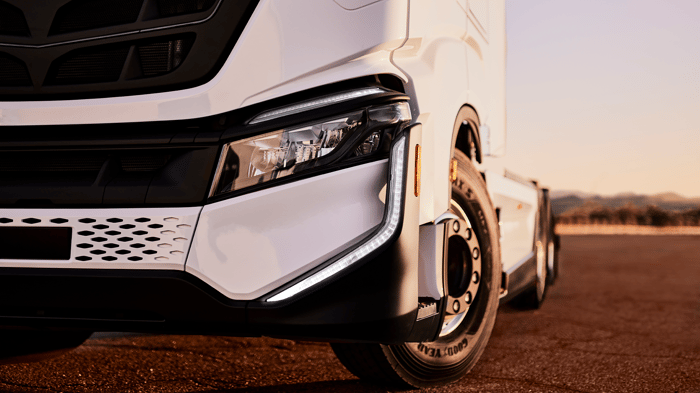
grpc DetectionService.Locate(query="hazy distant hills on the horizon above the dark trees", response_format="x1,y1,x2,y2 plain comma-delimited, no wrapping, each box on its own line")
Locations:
550,190,700,215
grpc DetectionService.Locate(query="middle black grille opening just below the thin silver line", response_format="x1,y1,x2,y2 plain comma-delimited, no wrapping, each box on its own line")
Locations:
48,46,129,85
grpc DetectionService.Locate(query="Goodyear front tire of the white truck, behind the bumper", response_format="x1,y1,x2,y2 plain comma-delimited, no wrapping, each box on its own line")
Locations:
331,150,502,388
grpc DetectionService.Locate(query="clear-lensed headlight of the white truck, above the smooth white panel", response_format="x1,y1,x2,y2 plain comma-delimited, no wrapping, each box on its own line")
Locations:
210,102,411,197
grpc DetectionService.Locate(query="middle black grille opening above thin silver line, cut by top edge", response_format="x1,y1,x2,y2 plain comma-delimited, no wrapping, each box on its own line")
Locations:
49,0,143,35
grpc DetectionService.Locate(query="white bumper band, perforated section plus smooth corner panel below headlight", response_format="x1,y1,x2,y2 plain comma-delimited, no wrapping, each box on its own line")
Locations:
0,160,388,300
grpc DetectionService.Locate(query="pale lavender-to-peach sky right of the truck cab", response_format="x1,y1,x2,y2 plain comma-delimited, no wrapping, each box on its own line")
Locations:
505,0,700,197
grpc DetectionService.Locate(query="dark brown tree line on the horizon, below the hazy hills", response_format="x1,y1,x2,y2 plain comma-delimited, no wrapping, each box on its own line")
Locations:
556,203,700,227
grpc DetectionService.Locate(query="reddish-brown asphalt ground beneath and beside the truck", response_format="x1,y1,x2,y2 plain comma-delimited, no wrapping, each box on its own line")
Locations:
0,236,700,393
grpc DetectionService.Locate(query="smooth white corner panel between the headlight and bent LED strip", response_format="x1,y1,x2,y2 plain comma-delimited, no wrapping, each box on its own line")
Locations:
187,160,388,300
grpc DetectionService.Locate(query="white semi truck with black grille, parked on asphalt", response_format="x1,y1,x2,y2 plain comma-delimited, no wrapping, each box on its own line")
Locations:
0,0,556,387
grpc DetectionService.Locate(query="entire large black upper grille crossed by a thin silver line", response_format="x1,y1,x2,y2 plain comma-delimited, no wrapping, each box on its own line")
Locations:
0,0,258,101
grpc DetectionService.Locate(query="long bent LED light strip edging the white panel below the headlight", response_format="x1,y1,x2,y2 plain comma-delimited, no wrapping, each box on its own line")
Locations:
267,136,406,302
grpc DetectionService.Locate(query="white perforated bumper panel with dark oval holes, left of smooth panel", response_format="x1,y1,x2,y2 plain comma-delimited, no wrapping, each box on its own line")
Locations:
0,208,200,267
